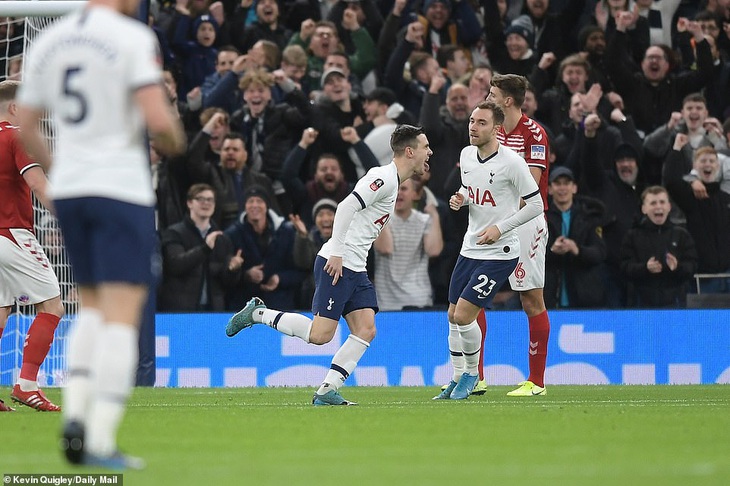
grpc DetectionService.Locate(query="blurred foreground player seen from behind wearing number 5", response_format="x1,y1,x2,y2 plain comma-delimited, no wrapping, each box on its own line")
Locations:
19,0,185,469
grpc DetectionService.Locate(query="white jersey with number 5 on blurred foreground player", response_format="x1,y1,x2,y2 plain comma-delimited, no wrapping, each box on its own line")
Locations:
18,7,162,206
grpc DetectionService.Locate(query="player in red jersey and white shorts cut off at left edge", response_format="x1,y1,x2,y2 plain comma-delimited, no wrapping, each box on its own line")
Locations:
0,81,64,412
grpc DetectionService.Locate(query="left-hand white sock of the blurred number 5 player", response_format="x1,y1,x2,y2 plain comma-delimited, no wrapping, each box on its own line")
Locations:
62,307,103,423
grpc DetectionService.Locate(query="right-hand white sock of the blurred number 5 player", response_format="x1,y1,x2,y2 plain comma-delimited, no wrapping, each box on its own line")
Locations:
84,323,139,456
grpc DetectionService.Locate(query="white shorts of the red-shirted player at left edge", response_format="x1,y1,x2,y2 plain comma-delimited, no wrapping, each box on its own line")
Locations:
0,228,61,307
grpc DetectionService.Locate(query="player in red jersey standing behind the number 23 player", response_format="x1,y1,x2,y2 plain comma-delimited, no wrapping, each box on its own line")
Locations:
486,74,550,397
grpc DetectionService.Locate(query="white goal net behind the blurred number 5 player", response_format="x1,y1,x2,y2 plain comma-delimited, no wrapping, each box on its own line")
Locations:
0,6,83,387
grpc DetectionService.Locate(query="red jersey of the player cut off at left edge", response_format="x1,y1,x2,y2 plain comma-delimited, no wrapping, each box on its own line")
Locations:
0,121,39,231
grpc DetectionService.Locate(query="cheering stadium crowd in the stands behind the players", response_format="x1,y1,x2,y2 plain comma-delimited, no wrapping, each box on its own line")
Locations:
5,0,730,312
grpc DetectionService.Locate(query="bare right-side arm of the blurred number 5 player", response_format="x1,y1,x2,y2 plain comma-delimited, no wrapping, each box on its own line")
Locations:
134,84,187,155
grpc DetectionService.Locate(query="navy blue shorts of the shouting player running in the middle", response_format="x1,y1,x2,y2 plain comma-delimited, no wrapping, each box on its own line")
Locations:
312,256,378,321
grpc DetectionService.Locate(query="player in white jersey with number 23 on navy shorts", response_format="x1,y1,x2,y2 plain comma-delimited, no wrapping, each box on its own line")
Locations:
434,101,542,400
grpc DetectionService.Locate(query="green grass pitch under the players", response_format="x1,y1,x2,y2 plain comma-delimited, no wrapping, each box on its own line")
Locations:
0,385,730,486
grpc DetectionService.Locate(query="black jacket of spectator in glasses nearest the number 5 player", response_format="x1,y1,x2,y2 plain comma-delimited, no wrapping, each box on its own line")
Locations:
157,216,240,312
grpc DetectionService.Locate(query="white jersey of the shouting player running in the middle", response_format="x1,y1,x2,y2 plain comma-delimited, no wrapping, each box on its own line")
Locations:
318,162,398,272
